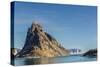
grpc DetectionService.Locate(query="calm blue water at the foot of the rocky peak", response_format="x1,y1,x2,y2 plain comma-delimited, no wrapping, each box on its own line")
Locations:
14,55,97,65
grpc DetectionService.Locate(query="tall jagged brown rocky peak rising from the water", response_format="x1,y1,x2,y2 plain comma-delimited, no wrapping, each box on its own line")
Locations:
17,23,69,57
